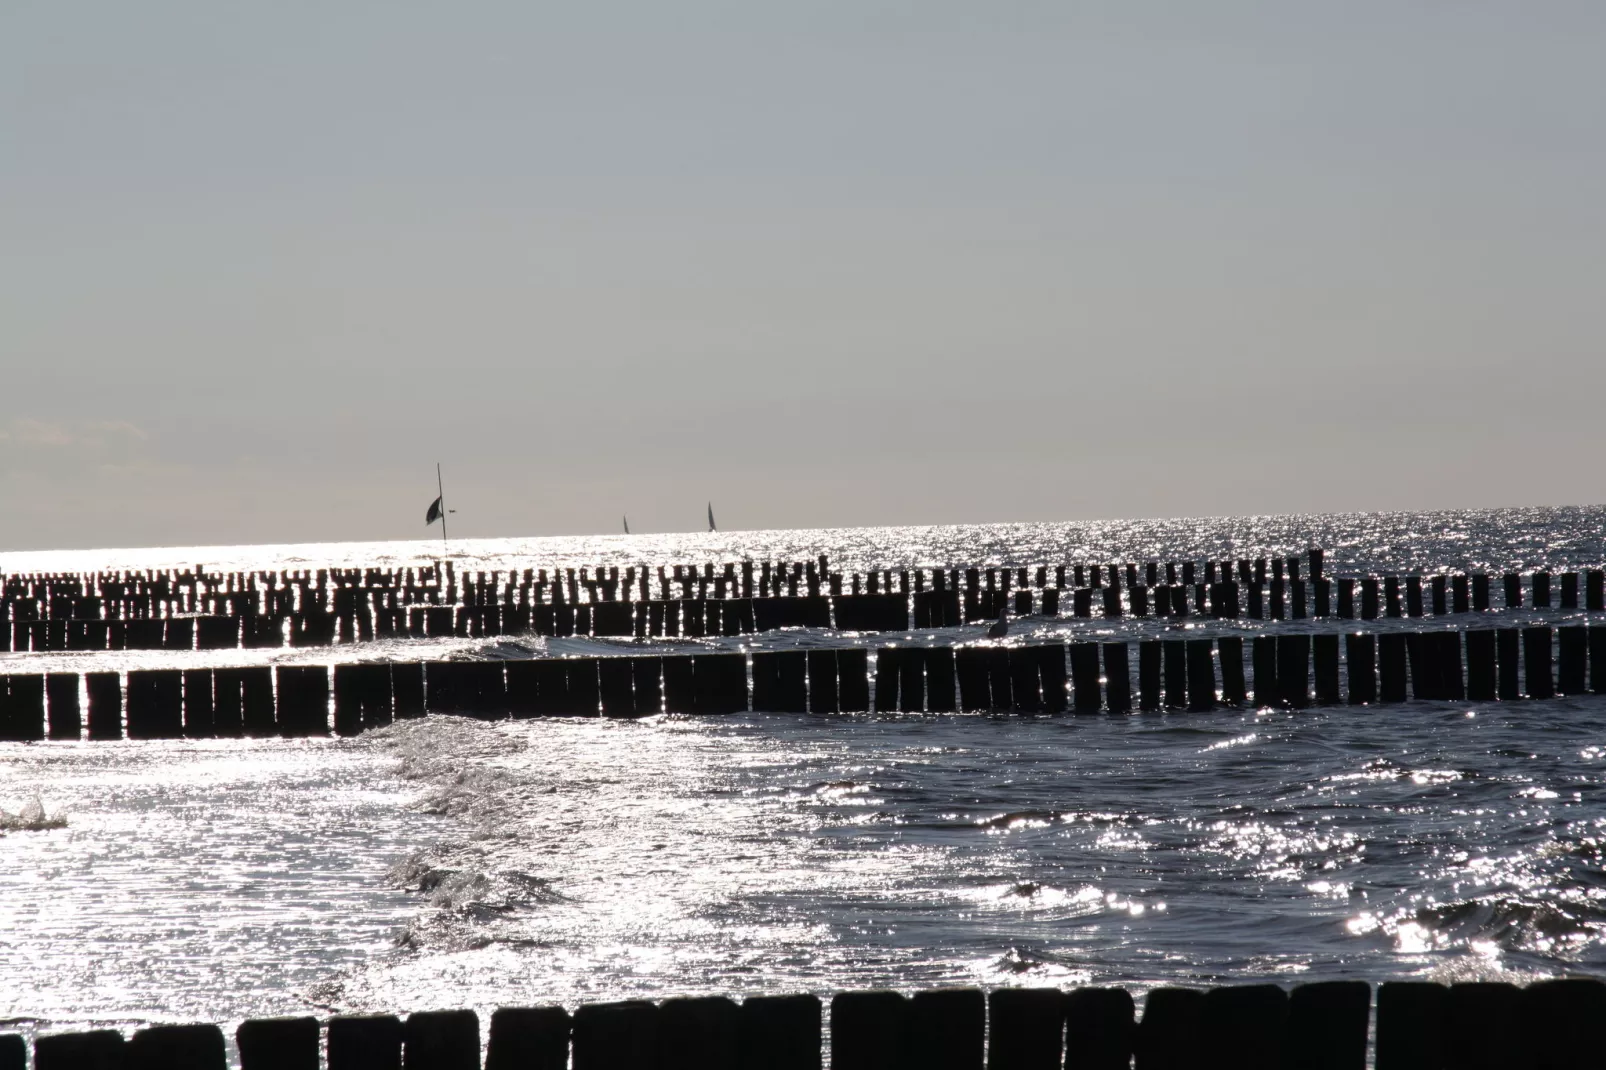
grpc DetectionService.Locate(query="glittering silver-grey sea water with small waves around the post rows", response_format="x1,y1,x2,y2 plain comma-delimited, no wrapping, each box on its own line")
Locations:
0,508,1606,1031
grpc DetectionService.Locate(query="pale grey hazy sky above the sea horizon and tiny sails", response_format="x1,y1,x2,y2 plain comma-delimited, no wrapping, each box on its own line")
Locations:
0,0,1606,549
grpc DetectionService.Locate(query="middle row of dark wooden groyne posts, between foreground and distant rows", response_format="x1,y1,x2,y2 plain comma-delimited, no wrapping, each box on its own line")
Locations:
0,625,1606,741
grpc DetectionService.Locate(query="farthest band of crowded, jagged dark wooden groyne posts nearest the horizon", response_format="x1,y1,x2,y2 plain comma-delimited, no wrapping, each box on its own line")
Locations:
0,549,1606,652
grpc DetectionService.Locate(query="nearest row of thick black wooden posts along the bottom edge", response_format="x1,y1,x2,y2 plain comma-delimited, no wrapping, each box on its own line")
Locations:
0,978,1606,1070
